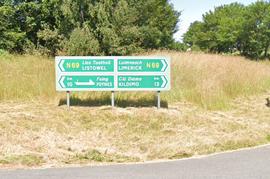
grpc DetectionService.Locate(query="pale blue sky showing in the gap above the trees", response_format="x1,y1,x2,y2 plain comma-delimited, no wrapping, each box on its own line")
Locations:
171,0,256,40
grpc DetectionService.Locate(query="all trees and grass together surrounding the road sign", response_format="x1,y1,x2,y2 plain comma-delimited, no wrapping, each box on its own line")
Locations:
0,0,270,168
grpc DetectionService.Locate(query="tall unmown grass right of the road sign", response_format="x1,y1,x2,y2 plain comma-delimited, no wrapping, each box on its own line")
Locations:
156,52,270,109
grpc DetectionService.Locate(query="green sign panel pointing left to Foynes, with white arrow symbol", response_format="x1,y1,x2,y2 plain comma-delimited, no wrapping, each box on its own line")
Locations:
59,76,114,90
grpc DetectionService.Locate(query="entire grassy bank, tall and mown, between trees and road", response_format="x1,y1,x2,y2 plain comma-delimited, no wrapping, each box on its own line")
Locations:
0,51,270,167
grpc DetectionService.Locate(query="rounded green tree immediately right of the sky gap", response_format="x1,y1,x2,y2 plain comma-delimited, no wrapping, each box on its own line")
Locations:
184,3,245,53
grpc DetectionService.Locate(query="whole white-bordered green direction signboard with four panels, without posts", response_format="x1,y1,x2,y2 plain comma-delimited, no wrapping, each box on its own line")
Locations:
55,56,171,91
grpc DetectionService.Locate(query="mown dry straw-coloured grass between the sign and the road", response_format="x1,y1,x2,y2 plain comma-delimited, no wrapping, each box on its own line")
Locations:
0,94,270,167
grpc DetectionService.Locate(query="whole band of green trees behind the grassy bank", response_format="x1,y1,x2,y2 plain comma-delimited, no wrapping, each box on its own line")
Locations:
0,0,270,60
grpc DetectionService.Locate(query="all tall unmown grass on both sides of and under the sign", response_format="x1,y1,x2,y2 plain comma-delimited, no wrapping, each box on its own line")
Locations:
0,51,270,109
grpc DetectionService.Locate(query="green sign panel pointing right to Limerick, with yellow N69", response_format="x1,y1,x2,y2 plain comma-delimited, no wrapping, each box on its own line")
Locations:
118,59,168,72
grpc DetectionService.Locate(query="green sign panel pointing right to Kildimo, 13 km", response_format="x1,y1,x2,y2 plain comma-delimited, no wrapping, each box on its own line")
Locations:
118,75,168,89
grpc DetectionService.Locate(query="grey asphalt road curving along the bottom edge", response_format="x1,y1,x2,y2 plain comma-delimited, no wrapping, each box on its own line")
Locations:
0,146,270,179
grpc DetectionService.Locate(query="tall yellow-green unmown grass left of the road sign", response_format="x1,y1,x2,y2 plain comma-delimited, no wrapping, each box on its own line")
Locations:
0,55,56,100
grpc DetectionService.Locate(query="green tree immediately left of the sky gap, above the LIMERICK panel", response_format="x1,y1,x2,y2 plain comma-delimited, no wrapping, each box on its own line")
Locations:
134,0,180,49
